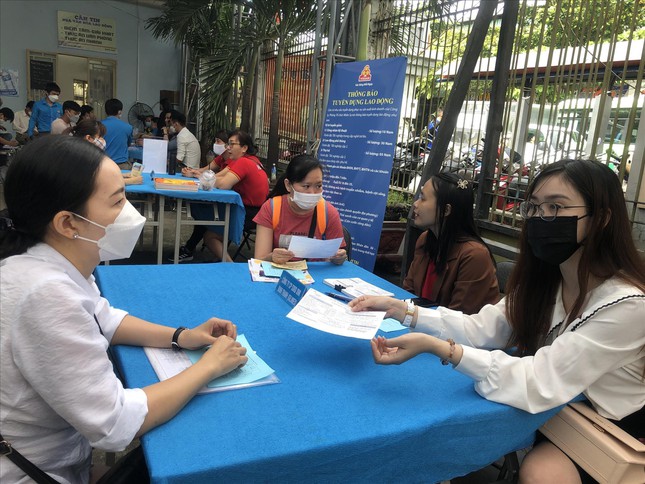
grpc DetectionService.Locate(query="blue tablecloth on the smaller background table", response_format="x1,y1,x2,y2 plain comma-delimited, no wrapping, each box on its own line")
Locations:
125,173,246,244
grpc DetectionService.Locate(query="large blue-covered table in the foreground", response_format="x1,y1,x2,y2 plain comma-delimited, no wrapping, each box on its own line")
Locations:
96,263,557,484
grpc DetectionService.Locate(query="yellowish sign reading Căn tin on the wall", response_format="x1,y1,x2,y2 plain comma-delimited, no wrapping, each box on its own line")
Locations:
58,10,117,54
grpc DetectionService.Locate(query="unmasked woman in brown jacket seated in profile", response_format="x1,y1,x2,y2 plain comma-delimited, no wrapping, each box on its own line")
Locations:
403,173,499,314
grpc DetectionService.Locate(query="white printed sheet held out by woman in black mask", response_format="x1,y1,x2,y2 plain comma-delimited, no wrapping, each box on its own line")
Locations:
287,289,385,339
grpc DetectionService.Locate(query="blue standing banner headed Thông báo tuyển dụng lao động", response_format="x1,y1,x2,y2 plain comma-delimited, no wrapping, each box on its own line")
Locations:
318,57,406,270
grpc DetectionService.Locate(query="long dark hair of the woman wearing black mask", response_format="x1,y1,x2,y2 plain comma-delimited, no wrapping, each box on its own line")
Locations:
506,160,645,355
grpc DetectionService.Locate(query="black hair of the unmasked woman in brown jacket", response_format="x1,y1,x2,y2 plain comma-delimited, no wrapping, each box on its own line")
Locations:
425,173,495,274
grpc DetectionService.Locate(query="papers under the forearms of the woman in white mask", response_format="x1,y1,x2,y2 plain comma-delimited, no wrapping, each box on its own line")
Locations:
144,335,280,393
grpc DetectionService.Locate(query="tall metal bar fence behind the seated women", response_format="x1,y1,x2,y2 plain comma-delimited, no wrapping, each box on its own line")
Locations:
249,0,645,246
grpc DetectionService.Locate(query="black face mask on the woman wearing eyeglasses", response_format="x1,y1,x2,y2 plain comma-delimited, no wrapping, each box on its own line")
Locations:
526,215,586,266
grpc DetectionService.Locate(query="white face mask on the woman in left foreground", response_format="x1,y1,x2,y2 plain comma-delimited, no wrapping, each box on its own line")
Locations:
74,200,146,261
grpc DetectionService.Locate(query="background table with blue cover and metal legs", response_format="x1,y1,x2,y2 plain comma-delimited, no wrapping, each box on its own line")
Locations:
125,173,246,264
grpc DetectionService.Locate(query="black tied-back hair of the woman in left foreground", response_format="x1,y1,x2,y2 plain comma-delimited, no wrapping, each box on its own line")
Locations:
0,136,105,259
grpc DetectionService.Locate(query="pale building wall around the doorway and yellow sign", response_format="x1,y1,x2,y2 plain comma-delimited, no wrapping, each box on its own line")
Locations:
0,0,181,113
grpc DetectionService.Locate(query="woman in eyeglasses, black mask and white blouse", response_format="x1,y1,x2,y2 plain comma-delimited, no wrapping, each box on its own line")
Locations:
350,160,645,483
